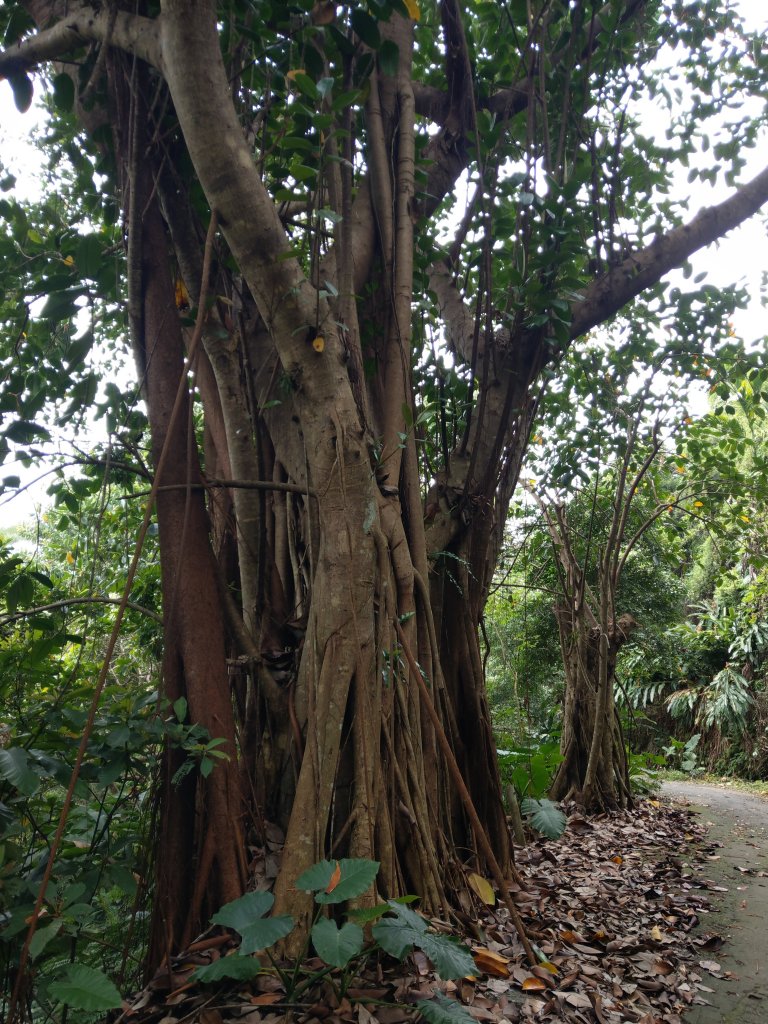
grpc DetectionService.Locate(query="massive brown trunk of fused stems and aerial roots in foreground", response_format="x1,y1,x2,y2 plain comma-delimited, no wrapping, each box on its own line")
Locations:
7,0,768,964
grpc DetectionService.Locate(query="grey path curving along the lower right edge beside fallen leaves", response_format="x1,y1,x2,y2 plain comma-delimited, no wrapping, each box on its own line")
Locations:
662,782,768,1024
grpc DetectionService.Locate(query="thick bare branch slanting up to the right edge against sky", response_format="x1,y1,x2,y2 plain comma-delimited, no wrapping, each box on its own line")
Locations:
570,162,768,340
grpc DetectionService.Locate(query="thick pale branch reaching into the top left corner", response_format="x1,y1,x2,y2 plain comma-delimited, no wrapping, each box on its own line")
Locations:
0,4,163,78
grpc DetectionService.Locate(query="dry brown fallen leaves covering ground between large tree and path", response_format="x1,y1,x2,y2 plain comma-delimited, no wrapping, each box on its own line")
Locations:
112,800,728,1024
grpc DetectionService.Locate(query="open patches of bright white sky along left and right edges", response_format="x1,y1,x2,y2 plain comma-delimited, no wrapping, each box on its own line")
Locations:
0,6,768,529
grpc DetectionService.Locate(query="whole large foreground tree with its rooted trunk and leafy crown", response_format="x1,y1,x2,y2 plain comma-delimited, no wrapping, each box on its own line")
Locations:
0,0,768,987
